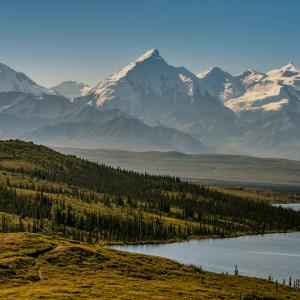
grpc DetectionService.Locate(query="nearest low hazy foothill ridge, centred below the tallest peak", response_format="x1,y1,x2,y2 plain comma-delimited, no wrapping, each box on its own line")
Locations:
23,116,209,153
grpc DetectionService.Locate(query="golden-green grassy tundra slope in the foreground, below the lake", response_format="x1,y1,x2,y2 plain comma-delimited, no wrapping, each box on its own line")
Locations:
0,233,300,299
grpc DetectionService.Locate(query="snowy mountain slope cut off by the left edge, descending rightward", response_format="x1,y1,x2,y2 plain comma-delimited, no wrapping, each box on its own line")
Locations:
0,63,56,94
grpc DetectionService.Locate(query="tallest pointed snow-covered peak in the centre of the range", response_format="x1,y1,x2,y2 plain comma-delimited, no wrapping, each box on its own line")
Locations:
75,49,231,119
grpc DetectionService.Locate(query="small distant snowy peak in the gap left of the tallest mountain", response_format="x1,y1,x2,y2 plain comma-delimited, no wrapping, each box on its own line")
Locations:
51,80,90,100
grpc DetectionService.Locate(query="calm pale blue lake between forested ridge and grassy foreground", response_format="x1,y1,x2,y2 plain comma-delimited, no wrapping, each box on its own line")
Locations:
111,204,300,282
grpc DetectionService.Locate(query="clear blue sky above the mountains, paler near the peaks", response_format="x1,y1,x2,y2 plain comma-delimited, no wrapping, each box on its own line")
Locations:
0,0,300,87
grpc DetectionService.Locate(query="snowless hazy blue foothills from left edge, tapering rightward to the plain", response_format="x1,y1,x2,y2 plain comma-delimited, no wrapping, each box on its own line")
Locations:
0,92,212,153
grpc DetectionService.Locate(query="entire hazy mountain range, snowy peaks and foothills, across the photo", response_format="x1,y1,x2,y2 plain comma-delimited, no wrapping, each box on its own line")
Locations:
0,49,300,159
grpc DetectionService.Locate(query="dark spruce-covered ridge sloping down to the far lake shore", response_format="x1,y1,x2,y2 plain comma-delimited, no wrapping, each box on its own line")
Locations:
0,140,300,242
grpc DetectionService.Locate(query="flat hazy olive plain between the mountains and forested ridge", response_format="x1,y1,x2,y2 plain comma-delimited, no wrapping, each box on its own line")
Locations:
57,148,300,189
